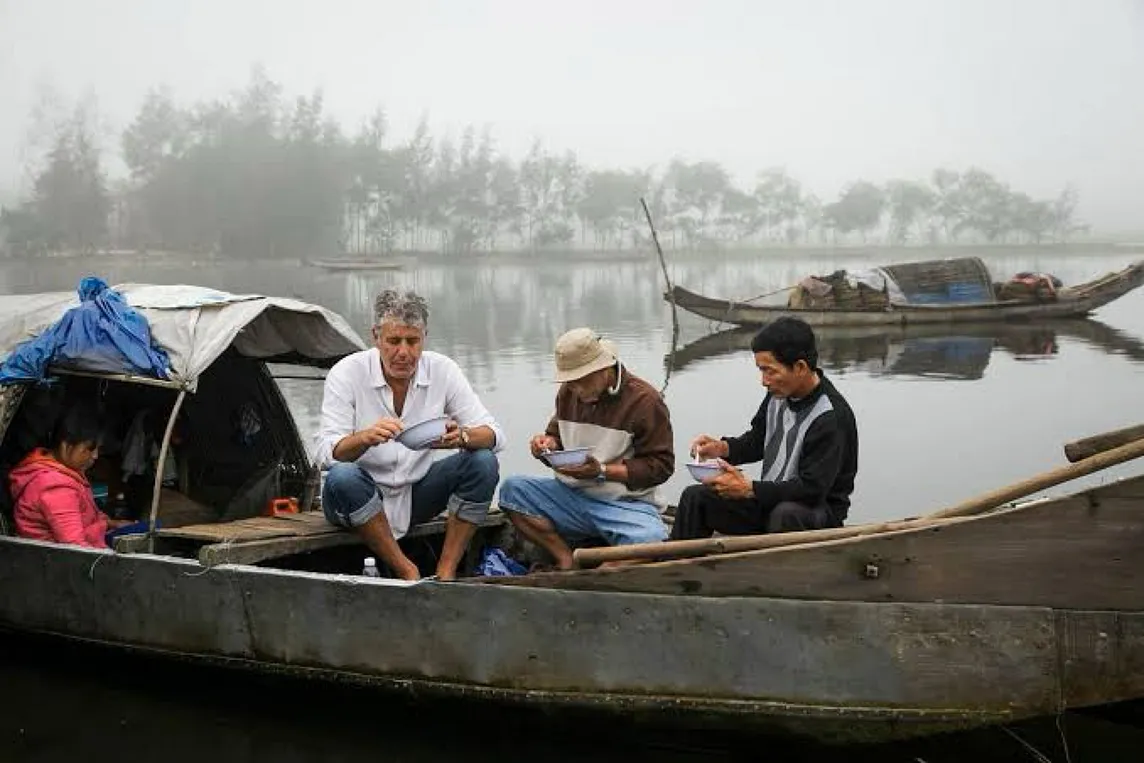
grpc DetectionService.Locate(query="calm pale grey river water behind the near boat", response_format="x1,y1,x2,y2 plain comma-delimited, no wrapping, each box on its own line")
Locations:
0,249,1144,520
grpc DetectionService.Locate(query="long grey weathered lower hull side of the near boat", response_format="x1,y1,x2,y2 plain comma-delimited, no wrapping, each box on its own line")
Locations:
0,538,1107,742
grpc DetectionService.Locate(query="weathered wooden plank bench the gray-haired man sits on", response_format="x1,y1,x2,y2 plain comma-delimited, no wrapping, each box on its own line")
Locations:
129,508,508,566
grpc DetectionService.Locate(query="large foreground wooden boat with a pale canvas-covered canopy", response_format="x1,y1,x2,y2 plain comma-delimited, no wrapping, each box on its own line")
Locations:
0,286,1144,741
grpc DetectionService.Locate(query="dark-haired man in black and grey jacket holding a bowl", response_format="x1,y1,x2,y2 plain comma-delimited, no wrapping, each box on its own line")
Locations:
672,318,858,540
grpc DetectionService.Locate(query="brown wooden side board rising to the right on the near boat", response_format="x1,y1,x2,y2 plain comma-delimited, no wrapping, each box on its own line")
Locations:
537,477,1144,608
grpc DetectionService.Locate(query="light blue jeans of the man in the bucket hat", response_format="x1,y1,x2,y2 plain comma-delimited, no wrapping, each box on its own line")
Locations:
499,477,667,546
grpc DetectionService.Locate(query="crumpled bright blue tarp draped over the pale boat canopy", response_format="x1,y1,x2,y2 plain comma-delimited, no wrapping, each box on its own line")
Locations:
0,276,170,384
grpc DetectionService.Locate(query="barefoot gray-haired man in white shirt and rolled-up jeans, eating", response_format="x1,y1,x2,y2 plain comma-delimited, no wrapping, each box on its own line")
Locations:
317,289,505,580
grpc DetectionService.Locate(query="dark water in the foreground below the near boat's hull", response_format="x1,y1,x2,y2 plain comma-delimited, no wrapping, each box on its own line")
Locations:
0,634,1144,763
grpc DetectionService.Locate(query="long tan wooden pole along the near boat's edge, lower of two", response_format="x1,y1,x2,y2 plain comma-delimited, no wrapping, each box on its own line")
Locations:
572,440,1144,567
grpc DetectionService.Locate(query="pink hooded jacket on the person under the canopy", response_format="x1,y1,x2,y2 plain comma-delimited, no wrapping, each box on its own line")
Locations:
8,448,108,548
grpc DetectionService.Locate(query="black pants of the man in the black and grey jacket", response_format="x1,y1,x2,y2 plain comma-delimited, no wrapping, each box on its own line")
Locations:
672,485,841,540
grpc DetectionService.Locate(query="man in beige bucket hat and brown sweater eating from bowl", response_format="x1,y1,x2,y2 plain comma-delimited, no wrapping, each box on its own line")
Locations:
498,328,675,570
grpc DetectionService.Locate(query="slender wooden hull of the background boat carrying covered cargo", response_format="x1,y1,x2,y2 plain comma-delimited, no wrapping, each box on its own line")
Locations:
664,261,1144,328
